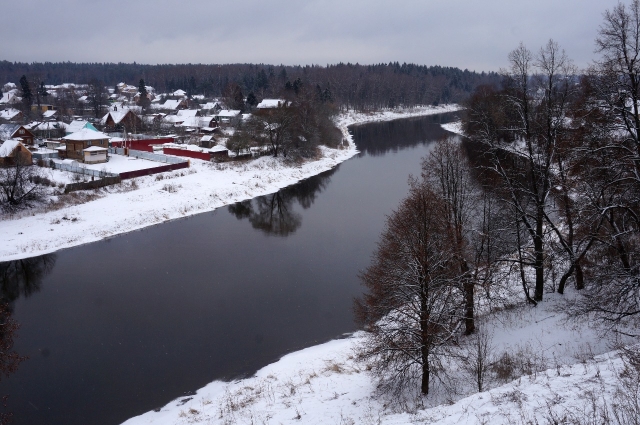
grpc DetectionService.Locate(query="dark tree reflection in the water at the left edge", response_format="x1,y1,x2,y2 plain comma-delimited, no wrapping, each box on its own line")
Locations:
0,254,56,424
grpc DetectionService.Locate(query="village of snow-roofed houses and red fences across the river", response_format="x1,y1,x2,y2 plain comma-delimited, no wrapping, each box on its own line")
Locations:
0,80,304,187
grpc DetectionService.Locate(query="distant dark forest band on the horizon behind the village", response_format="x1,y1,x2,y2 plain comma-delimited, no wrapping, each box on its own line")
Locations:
0,61,499,110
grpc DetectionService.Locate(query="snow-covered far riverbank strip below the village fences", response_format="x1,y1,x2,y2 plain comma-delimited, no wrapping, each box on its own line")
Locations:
0,105,460,261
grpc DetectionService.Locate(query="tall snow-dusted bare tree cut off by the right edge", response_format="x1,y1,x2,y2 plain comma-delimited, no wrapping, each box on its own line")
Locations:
564,0,640,330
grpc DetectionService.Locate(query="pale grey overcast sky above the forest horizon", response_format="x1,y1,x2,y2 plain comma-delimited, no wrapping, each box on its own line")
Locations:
0,0,629,71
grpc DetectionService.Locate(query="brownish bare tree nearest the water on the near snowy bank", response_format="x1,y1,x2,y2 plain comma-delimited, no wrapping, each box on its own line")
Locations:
356,181,463,394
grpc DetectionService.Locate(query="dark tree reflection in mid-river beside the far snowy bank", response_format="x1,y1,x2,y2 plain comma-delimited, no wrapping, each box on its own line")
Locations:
228,167,338,236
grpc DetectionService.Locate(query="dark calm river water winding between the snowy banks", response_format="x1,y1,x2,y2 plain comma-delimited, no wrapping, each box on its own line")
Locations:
0,114,454,424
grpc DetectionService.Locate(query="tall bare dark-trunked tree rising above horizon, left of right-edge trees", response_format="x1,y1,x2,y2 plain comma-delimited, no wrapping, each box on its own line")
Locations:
466,40,580,302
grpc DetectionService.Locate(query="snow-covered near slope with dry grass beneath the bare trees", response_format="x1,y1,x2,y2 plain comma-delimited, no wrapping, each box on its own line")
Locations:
125,294,636,425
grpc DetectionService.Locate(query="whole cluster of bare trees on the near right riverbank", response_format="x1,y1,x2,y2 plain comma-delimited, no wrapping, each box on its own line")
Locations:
356,0,640,402
